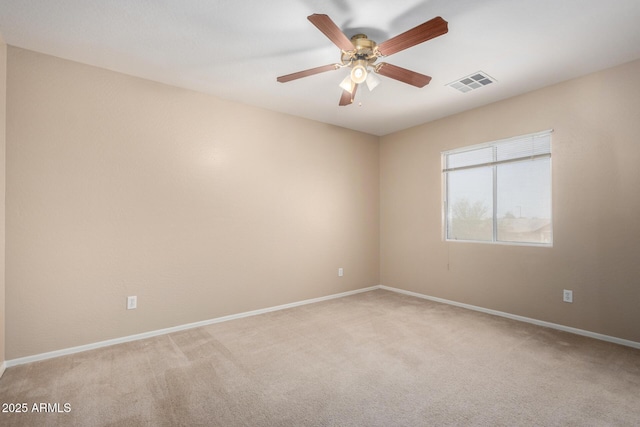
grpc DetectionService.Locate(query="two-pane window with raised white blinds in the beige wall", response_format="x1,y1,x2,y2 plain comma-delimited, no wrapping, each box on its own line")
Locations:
442,131,552,246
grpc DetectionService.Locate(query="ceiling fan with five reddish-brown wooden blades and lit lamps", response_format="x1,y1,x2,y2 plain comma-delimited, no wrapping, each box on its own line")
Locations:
277,13,449,106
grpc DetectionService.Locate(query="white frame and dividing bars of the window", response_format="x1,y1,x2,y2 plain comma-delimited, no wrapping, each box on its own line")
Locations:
441,129,554,248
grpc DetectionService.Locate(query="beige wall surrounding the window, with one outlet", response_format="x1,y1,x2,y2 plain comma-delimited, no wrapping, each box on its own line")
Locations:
380,57,640,342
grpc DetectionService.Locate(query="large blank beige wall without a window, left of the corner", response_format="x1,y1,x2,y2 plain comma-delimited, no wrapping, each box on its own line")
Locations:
6,47,379,360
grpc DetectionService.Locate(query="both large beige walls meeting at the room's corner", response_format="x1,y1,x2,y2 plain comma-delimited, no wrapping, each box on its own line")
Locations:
5,47,640,360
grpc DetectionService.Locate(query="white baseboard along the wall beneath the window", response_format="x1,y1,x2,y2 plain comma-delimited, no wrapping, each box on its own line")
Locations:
378,285,640,349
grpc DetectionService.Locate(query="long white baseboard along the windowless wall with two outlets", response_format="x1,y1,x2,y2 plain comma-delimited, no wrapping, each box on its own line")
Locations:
3,286,379,369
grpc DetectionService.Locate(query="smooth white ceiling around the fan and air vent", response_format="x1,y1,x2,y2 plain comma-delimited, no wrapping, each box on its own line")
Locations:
0,0,640,135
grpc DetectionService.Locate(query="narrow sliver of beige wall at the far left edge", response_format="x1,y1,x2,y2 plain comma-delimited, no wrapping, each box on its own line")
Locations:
0,35,7,375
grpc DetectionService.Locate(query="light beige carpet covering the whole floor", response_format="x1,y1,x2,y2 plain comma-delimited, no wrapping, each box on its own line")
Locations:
0,290,640,427
